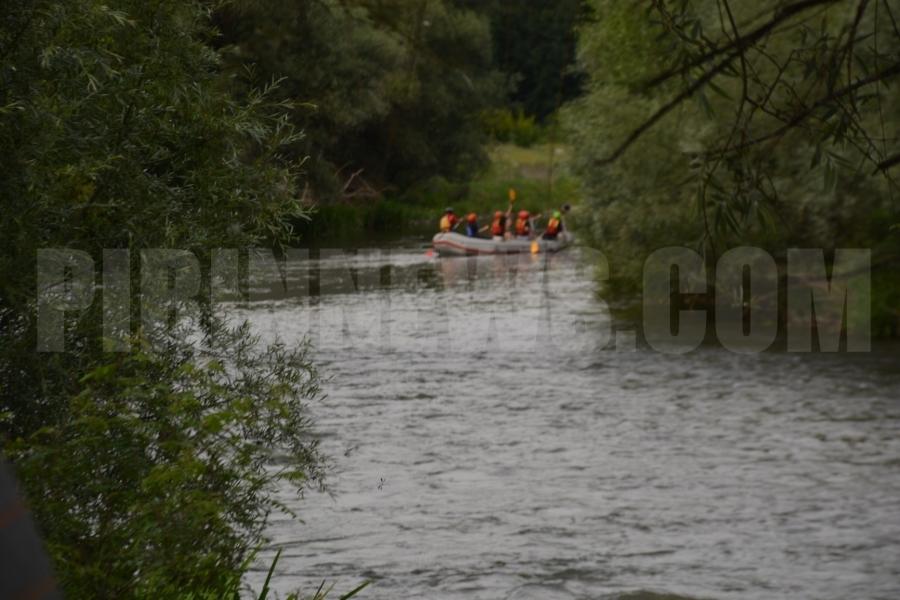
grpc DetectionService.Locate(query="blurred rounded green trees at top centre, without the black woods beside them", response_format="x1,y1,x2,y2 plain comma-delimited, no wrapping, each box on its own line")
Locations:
217,0,503,201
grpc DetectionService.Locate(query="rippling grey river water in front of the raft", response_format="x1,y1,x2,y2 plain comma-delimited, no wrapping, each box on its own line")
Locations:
243,238,900,600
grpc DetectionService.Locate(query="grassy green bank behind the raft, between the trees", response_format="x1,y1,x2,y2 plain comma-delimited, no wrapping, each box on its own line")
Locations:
297,144,578,239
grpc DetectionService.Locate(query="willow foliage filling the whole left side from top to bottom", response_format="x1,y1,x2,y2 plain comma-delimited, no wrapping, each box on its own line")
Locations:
0,0,322,598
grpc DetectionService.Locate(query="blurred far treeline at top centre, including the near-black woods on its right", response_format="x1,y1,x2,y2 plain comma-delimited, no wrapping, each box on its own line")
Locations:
216,0,585,203
